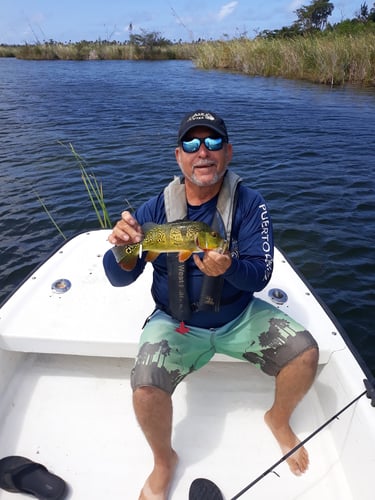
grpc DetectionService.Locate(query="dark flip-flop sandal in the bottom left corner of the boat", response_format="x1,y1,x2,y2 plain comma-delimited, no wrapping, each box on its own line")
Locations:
0,455,68,500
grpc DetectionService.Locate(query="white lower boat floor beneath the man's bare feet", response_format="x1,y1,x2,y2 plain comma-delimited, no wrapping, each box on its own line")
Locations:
0,354,360,500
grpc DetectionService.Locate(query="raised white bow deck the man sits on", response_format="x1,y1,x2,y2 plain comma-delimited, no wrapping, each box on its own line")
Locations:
0,230,346,364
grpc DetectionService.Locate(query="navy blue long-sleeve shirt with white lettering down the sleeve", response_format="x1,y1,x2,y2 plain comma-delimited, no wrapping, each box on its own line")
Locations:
103,183,273,328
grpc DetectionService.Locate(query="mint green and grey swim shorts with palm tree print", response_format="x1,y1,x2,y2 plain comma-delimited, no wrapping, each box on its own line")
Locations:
131,298,318,394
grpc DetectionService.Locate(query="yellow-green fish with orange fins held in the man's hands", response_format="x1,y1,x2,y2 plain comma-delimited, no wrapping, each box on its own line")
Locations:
112,220,227,271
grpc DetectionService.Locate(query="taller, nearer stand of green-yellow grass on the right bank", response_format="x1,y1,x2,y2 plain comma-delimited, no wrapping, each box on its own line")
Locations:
194,33,375,85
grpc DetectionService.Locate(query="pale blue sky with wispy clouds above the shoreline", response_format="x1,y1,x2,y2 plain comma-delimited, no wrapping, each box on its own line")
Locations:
0,0,364,44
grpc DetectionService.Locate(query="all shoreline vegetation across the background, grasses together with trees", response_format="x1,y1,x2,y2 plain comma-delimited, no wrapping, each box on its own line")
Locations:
0,0,375,87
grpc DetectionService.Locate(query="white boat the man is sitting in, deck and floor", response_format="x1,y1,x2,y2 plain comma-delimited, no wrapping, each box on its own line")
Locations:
0,230,375,500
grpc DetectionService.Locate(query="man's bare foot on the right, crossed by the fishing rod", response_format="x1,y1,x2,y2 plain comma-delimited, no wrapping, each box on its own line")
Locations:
264,411,309,476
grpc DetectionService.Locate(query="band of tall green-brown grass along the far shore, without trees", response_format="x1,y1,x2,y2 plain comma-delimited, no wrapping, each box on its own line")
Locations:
0,32,375,86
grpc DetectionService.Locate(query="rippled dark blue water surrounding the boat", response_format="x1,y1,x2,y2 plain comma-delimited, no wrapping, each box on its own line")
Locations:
0,59,375,371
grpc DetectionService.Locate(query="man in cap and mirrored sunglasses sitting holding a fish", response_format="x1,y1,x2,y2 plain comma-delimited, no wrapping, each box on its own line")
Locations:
104,110,318,500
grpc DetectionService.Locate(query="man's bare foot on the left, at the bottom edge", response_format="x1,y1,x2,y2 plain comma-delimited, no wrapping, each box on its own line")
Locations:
139,450,178,500
